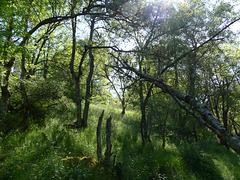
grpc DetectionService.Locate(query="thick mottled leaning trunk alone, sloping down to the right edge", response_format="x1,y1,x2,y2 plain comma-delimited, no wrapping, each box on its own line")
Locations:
123,63,240,154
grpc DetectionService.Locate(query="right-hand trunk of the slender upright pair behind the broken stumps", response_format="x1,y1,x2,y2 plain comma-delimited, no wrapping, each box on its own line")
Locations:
83,18,95,128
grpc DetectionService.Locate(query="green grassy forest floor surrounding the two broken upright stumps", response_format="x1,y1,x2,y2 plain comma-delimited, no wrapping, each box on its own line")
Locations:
0,105,240,180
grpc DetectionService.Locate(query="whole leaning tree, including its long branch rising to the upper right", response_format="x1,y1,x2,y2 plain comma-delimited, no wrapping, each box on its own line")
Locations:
109,0,240,153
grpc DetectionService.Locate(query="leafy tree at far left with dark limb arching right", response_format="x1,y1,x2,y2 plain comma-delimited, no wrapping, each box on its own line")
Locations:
0,1,127,129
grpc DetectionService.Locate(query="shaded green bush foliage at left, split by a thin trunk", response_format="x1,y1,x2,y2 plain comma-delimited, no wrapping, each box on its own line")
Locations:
1,78,65,134
